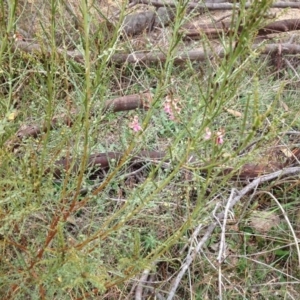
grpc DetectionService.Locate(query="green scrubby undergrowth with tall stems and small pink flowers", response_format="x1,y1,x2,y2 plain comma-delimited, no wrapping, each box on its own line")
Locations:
0,0,300,299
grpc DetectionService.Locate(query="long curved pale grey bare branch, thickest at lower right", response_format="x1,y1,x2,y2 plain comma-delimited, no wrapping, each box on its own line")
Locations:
167,167,300,300
